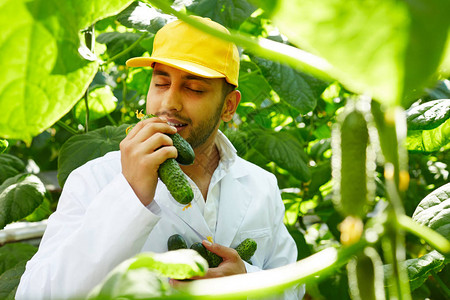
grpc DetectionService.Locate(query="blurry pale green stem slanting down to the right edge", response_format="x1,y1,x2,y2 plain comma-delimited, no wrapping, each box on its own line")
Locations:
397,215,450,255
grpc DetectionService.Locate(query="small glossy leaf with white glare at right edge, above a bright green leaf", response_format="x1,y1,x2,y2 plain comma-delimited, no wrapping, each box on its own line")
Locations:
406,99,450,130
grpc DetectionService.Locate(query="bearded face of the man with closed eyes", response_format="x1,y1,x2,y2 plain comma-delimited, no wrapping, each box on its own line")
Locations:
147,63,224,148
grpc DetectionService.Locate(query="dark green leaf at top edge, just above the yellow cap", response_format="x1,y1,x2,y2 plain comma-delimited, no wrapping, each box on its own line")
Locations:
186,0,255,29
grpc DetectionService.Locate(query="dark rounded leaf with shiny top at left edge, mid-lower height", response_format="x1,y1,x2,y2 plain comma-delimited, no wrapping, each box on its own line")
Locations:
0,174,45,229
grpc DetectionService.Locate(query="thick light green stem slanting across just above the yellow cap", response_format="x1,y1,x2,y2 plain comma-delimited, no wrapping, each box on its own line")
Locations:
147,0,334,80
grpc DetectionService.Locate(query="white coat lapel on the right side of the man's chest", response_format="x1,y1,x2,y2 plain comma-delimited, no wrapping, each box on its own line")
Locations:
215,165,252,247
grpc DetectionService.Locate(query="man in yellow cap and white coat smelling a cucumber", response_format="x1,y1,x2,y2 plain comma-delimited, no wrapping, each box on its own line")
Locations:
17,17,301,299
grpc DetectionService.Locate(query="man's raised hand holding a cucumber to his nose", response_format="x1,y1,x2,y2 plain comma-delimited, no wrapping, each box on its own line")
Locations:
120,117,178,206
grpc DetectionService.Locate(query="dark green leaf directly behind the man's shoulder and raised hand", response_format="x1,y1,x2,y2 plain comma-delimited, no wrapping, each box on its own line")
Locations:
58,124,129,187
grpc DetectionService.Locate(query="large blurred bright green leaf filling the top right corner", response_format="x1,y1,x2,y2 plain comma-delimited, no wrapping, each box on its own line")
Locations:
274,0,450,107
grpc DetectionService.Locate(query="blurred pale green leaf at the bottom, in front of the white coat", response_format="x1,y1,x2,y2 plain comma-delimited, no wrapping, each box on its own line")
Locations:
89,249,208,299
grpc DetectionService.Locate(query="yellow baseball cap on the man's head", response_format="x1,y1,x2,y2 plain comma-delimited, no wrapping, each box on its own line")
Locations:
127,16,239,86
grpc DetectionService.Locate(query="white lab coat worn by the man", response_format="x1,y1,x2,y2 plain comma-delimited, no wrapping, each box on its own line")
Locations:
16,133,303,299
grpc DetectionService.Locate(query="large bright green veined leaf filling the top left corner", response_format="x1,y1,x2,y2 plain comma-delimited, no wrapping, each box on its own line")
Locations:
0,0,132,142
